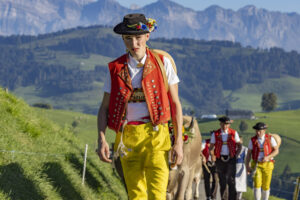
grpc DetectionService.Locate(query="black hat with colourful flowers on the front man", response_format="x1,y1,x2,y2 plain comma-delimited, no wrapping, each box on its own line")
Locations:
114,13,157,35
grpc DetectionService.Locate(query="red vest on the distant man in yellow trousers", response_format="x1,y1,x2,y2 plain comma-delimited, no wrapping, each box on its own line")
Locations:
251,134,272,161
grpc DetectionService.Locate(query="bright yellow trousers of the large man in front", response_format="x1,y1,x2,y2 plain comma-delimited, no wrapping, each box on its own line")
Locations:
114,123,171,200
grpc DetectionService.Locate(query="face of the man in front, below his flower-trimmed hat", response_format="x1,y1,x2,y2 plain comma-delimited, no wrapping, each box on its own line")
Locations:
122,33,150,61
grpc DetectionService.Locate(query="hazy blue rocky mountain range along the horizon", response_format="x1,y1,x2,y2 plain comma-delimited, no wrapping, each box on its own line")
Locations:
0,0,300,51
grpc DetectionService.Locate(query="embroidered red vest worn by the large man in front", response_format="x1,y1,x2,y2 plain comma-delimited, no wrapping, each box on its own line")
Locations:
107,48,170,132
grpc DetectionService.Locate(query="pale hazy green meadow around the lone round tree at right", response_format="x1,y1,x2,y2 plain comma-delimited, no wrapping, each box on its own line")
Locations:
224,77,300,112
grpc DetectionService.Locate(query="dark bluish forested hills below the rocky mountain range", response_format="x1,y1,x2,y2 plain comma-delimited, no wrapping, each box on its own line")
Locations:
0,26,300,113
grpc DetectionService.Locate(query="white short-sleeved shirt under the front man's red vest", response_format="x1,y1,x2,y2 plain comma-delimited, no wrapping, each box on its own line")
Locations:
102,54,179,121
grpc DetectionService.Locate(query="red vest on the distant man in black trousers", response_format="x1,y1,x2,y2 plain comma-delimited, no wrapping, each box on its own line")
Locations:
214,128,236,158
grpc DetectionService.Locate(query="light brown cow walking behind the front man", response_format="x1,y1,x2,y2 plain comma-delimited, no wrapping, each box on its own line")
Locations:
167,116,202,200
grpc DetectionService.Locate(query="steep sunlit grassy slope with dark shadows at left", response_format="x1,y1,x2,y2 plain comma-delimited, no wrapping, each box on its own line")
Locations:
0,89,127,200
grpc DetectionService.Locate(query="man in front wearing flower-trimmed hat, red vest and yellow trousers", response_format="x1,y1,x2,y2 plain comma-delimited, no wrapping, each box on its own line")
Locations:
97,14,183,200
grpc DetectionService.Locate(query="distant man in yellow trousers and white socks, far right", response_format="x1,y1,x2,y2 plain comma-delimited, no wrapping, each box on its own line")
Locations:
246,122,279,200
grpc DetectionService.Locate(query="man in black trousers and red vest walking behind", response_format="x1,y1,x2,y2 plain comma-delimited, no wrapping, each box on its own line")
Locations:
210,116,241,200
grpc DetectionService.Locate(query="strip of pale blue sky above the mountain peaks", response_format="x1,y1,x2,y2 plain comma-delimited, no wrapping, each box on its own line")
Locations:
116,0,300,14
